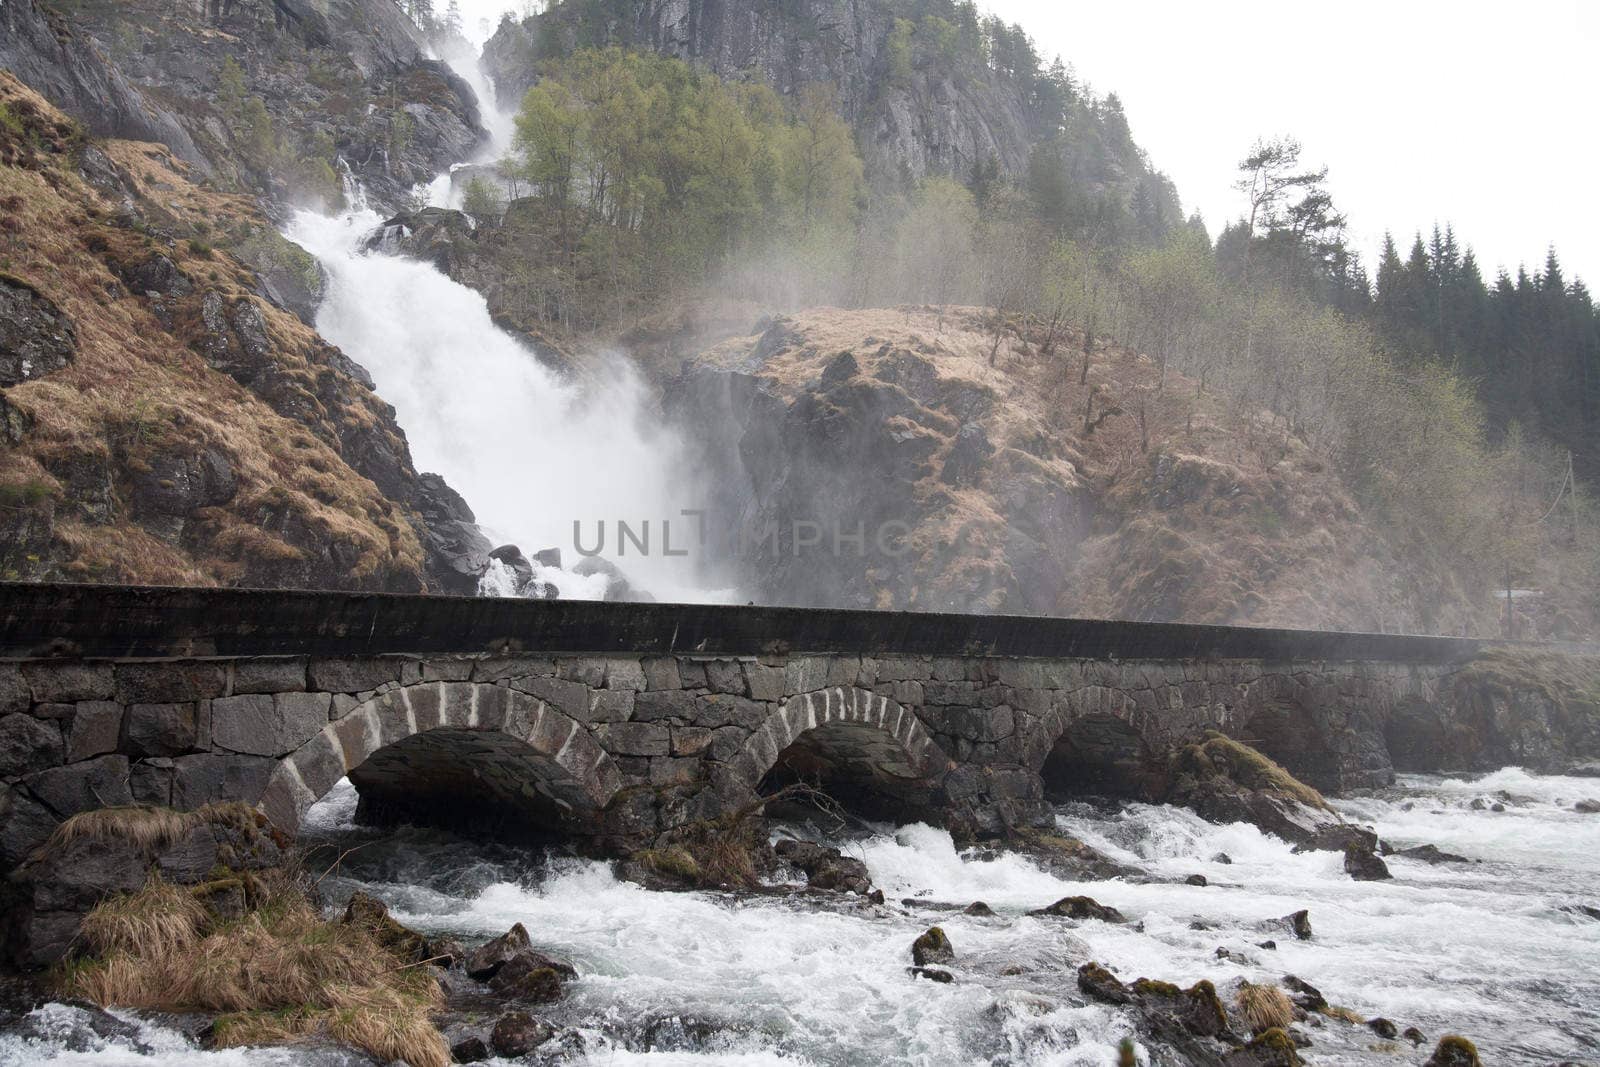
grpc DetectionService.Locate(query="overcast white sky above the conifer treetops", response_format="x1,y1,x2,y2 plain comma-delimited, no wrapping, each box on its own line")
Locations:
462,0,1600,290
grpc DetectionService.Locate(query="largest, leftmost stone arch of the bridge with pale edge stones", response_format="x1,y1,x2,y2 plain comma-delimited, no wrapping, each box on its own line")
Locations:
259,681,622,835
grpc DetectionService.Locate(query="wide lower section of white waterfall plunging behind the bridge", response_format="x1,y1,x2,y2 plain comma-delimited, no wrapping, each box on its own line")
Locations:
288,210,723,601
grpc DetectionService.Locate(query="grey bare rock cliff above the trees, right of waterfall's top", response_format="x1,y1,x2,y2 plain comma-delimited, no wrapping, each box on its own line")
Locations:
483,0,1050,179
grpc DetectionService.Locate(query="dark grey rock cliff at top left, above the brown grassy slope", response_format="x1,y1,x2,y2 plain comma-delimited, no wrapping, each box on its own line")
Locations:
10,0,483,214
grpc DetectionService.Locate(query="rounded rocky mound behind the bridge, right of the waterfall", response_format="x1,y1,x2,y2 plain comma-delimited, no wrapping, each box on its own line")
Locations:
667,307,1493,633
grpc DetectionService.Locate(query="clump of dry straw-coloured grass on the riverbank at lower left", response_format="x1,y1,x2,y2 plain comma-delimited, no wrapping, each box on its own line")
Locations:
61,878,450,1067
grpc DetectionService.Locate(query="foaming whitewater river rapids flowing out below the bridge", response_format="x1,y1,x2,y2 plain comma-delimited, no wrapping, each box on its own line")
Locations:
0,769,1600,1067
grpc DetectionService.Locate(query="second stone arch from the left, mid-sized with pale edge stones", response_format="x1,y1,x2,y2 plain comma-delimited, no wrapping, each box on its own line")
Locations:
733,686,952,816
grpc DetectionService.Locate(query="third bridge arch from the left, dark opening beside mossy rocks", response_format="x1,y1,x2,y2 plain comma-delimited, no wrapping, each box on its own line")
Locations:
1022,700,1166,800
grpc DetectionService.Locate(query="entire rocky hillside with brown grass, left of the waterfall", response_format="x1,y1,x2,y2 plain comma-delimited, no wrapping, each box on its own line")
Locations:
0,74,488,592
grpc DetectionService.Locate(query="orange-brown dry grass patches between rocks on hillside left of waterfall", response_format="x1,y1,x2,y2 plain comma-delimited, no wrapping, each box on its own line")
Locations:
0,72,422,587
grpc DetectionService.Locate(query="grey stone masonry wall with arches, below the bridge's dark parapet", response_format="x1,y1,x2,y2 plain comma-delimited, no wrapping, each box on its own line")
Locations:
0,654,1450,869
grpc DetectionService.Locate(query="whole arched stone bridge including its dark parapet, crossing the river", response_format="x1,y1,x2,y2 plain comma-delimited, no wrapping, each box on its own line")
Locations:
0,584,1523,869
